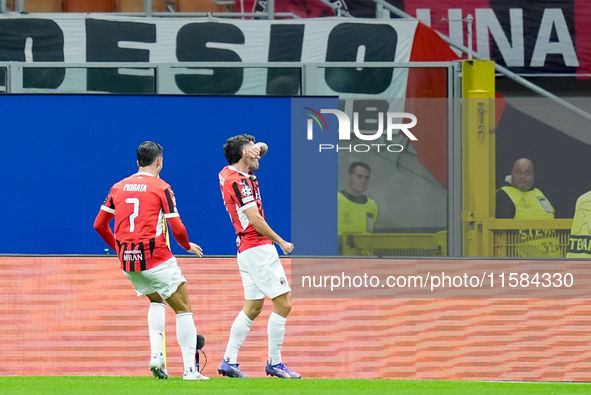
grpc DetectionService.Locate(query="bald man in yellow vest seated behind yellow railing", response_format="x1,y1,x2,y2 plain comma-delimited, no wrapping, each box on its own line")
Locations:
496,158,554,219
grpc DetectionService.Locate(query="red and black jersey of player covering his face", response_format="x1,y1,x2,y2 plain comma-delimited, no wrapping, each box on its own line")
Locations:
219,166,273,252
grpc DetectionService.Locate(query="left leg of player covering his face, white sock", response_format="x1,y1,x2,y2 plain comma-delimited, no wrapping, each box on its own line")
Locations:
218,299,265,378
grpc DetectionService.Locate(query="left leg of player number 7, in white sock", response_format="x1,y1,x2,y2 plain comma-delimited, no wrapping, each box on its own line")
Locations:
146,293,168,379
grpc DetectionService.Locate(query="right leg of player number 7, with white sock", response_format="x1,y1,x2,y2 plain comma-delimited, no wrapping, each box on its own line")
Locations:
166,283,209,380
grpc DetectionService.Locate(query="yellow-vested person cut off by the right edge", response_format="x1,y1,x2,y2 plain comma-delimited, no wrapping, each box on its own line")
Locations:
566,191,591,259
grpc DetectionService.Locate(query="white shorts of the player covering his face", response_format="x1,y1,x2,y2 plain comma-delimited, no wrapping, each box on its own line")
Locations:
238,244,291,300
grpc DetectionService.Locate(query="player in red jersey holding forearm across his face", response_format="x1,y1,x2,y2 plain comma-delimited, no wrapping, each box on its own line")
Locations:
218,134,301,378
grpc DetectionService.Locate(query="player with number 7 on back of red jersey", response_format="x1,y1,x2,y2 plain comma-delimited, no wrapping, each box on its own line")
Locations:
94,141,208,380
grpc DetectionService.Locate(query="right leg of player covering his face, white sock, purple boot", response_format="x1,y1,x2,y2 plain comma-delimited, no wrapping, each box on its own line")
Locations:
265,292,302,379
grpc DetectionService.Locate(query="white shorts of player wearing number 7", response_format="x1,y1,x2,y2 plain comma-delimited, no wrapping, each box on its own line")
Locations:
124,257,187,300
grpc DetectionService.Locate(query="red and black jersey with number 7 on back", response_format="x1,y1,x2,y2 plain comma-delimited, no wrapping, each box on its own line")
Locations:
101,172,179,272
